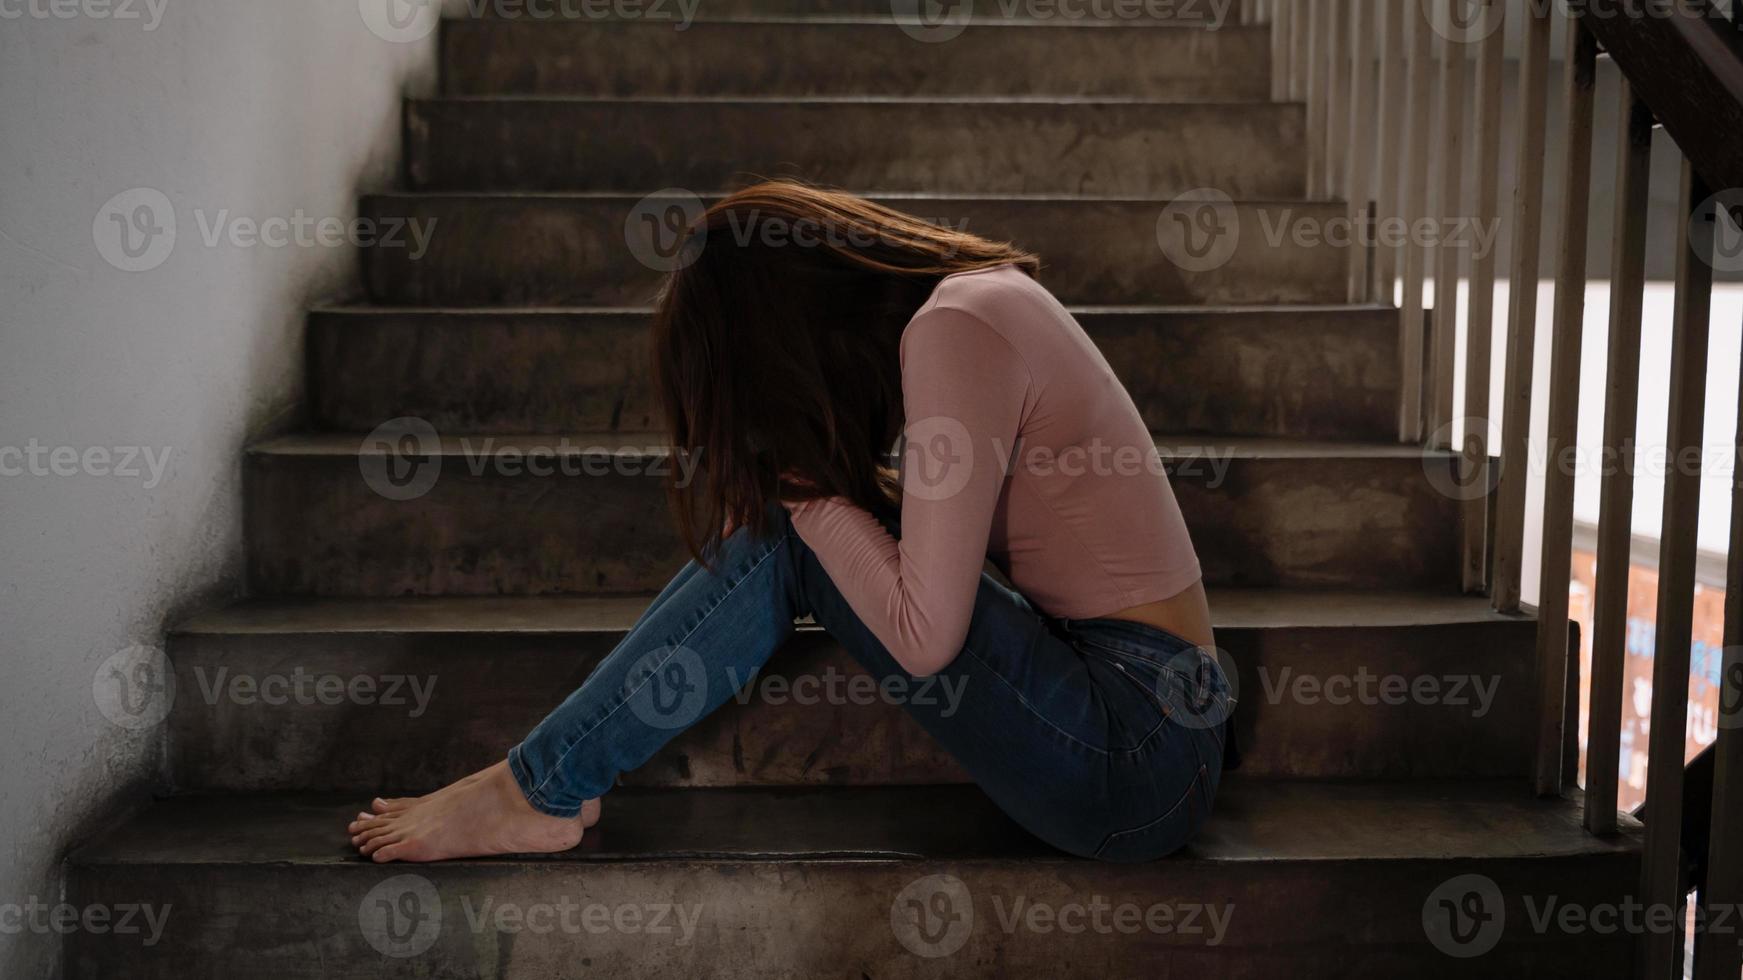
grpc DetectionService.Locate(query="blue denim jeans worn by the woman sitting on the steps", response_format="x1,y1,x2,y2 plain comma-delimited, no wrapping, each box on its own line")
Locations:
509,509,1232,861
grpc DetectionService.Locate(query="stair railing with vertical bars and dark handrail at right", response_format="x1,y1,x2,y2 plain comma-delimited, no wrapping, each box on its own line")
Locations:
1241,0,1743,980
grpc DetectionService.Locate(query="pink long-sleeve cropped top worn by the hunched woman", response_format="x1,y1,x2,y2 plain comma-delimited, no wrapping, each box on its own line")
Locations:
788,265,1201,675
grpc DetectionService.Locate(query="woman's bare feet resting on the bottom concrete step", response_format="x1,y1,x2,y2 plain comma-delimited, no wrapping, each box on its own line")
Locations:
349,762,600,863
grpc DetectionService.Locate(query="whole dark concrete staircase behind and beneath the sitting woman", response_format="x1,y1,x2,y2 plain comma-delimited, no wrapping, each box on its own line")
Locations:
68,9,1638,980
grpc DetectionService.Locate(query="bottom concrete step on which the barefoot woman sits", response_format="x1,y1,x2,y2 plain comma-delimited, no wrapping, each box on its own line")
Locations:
66,779,1640,980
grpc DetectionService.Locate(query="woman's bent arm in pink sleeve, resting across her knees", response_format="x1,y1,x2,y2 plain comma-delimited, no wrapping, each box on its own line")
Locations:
788,309,1032,675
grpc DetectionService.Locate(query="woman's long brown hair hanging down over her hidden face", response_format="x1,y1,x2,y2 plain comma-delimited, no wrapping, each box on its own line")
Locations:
652,181,1039,561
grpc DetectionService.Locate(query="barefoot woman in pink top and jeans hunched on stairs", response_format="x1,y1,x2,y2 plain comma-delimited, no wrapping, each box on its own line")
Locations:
350,181,1232,861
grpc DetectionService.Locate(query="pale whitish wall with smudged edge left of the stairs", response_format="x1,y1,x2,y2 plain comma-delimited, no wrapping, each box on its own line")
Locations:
0,0,434,978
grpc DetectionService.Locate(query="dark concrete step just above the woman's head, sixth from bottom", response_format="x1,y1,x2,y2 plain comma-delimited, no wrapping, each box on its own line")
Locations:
406,97,1307,199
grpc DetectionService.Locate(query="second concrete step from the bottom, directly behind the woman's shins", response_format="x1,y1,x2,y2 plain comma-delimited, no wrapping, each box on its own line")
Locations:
169,589,1536,784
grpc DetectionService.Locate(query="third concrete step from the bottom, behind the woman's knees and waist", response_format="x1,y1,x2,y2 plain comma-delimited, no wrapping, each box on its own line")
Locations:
244,432,1461,585
